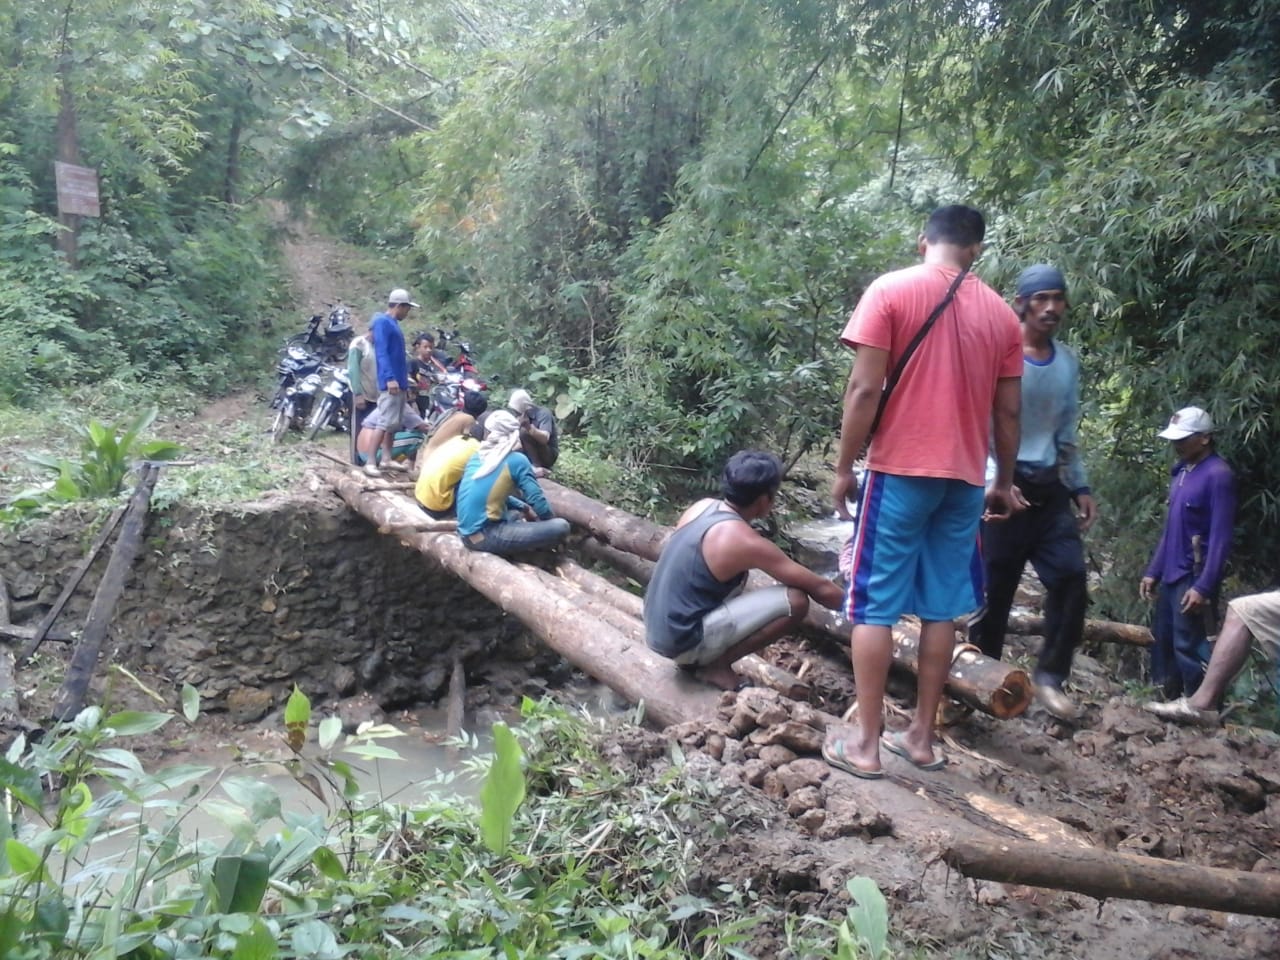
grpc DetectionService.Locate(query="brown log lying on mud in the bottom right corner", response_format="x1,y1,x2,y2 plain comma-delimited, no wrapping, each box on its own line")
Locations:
942,837,1280,918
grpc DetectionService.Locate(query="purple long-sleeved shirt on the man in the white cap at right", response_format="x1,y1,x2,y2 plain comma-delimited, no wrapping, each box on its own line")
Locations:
1146,453,1235,596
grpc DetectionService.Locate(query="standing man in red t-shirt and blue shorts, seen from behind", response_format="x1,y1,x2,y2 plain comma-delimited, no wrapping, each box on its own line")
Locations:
823,205,1023,778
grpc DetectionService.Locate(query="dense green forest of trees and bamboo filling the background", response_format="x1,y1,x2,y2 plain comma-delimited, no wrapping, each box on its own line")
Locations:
0,0,1280,616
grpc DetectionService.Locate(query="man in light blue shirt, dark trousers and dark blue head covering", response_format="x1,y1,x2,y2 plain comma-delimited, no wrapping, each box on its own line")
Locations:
969,264,1097,719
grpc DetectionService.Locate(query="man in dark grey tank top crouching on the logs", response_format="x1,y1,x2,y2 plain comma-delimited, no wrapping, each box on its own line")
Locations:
644,451,844,690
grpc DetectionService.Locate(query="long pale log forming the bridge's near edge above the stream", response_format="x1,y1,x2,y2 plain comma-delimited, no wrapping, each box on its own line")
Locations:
326,472,721,726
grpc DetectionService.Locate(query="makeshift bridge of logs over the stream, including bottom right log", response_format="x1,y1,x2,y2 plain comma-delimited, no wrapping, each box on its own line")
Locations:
320,467,1280,918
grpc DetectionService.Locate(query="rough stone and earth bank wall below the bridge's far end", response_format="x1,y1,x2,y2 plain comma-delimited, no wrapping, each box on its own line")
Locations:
0,490,529,721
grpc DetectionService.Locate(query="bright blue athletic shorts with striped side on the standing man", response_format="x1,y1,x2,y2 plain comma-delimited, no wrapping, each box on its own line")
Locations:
845,471,983,627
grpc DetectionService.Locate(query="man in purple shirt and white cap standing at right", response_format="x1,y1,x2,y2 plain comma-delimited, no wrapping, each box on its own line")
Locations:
1138,407,1235,699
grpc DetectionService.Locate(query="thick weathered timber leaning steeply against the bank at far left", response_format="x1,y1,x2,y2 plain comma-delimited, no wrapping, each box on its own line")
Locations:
54,463,160,721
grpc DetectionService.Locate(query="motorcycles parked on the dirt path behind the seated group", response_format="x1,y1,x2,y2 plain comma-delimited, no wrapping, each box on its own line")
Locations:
270,303,489,443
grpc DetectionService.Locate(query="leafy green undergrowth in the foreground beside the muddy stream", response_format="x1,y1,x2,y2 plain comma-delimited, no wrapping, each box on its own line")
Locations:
0,691,819,960
